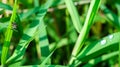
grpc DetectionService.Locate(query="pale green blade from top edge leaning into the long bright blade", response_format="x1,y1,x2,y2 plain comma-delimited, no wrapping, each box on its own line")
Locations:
65,0,82,33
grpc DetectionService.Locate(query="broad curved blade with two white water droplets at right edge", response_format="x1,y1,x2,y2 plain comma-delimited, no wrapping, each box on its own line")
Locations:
75,32,120,66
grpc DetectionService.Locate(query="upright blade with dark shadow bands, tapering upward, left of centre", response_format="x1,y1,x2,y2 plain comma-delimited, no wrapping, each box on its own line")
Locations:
37,21,50,63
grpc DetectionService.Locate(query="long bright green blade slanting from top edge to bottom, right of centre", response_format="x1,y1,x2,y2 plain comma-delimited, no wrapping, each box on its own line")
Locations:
69,0,100,64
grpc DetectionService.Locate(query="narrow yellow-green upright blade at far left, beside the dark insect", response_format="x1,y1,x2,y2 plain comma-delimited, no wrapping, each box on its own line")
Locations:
1,0,17,65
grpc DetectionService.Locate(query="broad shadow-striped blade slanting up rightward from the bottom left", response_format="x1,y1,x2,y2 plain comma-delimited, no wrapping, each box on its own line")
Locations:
7,20,40,63
